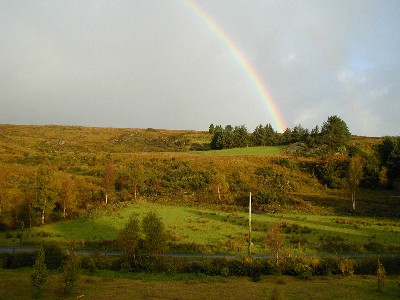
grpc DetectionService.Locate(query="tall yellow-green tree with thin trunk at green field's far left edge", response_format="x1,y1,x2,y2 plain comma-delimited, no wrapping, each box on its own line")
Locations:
32,166,58,225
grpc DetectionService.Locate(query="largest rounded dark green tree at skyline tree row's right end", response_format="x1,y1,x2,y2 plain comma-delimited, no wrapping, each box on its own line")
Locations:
320,116,351,150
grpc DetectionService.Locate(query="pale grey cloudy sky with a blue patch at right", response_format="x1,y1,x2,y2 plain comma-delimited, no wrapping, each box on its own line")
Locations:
0,0,400,136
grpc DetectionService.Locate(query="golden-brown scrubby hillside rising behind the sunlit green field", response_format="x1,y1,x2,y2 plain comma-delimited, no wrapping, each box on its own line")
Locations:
0,125,400,232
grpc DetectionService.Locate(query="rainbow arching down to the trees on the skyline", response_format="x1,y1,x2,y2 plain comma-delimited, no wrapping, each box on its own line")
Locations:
184,0,287,132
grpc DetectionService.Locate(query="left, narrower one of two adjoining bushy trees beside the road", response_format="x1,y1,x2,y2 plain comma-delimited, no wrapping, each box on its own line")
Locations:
117,215,140,262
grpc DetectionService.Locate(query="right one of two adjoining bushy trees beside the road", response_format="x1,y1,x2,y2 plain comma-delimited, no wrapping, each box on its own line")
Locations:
142,212,168,256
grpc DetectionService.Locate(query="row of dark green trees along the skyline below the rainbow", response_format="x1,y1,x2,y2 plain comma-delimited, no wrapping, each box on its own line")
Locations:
209,116,351,150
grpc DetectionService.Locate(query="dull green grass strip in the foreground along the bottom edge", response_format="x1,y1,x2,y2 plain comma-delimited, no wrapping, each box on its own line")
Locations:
0,268,400,300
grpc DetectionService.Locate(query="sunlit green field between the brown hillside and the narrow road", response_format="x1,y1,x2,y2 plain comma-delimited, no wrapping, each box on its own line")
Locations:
0,201,400,254
